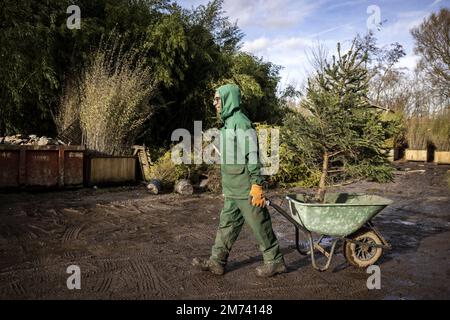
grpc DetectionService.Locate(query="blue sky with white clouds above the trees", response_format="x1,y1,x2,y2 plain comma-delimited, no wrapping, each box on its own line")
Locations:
177,0,450,87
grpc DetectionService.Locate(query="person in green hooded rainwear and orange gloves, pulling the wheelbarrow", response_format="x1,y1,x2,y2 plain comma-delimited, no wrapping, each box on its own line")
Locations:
193,84,286,277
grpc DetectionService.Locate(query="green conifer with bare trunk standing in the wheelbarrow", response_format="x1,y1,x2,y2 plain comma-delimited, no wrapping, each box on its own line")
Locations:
284,42,394,203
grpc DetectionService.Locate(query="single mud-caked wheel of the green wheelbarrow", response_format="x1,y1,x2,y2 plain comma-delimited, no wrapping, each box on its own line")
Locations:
344,229,383,268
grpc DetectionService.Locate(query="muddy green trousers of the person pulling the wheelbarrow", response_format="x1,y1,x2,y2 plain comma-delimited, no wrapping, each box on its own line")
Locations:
210,198,283,265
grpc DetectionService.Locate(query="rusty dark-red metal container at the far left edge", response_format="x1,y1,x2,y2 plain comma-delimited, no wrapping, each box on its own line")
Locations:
0,145,84,189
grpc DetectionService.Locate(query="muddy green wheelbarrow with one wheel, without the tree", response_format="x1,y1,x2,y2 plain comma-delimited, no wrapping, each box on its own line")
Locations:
267,193,392,272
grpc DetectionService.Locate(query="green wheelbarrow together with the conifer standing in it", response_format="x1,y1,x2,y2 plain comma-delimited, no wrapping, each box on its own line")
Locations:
269,42,396,271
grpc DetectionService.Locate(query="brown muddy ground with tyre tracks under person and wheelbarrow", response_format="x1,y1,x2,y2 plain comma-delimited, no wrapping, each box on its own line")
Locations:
0,164,450,299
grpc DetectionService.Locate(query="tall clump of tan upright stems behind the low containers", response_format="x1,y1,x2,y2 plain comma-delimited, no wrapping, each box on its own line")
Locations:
77,34,155,155
